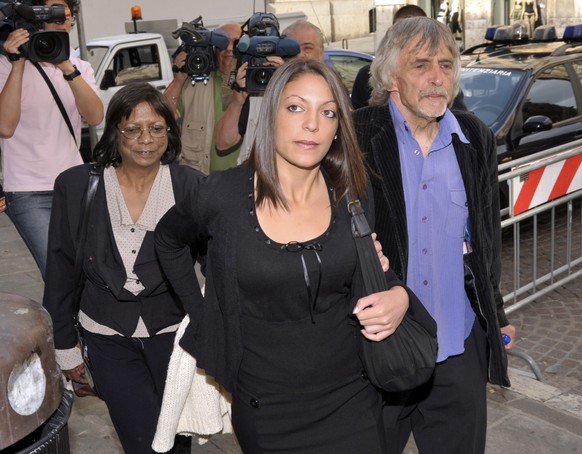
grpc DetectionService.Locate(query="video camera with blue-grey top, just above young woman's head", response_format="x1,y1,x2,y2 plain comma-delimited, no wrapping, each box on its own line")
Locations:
236,13,301,96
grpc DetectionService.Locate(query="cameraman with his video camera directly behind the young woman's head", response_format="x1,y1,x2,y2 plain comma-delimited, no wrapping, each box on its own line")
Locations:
216,13,323,164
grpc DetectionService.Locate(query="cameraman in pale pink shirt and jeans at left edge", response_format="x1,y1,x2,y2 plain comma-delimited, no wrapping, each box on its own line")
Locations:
0,0,103,279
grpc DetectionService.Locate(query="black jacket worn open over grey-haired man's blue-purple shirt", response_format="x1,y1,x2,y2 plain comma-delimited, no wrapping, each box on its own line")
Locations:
354,105,509,386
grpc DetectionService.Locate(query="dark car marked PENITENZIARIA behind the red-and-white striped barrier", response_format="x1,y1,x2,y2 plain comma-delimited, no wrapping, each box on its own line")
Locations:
461,25,582,206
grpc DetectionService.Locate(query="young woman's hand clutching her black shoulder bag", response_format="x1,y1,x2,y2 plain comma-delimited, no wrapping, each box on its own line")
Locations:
353,286,409,341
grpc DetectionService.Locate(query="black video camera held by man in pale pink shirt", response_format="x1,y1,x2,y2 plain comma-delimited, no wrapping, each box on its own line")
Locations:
0,0,70,63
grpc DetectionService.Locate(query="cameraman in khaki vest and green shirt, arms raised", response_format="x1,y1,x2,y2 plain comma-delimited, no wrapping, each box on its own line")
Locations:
164,22,242,175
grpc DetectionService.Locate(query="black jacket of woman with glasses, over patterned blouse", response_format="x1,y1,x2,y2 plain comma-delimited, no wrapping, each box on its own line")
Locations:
43,164,203,349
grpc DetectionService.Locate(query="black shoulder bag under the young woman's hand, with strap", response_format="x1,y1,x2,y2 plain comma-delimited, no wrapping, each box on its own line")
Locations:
348,200,437,392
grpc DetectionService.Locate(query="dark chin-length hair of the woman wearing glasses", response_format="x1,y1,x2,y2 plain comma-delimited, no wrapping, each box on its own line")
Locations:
93,82,182,167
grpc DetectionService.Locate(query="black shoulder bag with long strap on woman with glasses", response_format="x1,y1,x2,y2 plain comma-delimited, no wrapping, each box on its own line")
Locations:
73,164,101,397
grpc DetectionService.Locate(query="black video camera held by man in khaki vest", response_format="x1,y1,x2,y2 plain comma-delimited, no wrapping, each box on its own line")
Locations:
172,16,230,85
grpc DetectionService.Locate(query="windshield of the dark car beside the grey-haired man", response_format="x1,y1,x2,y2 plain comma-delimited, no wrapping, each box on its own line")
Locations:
461,68,525,126
